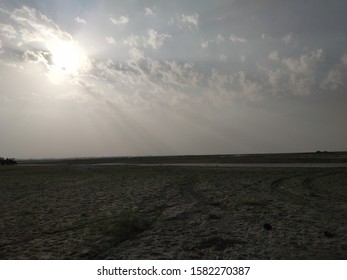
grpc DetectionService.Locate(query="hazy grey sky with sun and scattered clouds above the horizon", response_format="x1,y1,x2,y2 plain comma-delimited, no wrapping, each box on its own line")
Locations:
0,0,347,159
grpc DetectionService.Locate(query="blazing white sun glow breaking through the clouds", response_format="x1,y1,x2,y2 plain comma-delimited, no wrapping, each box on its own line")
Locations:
48,40,90,82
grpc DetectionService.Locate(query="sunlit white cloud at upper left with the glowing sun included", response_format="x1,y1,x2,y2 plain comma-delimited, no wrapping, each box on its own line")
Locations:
1,6,91,86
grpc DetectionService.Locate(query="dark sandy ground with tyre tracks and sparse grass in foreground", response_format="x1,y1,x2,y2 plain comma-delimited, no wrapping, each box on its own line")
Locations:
0,165,347,259
